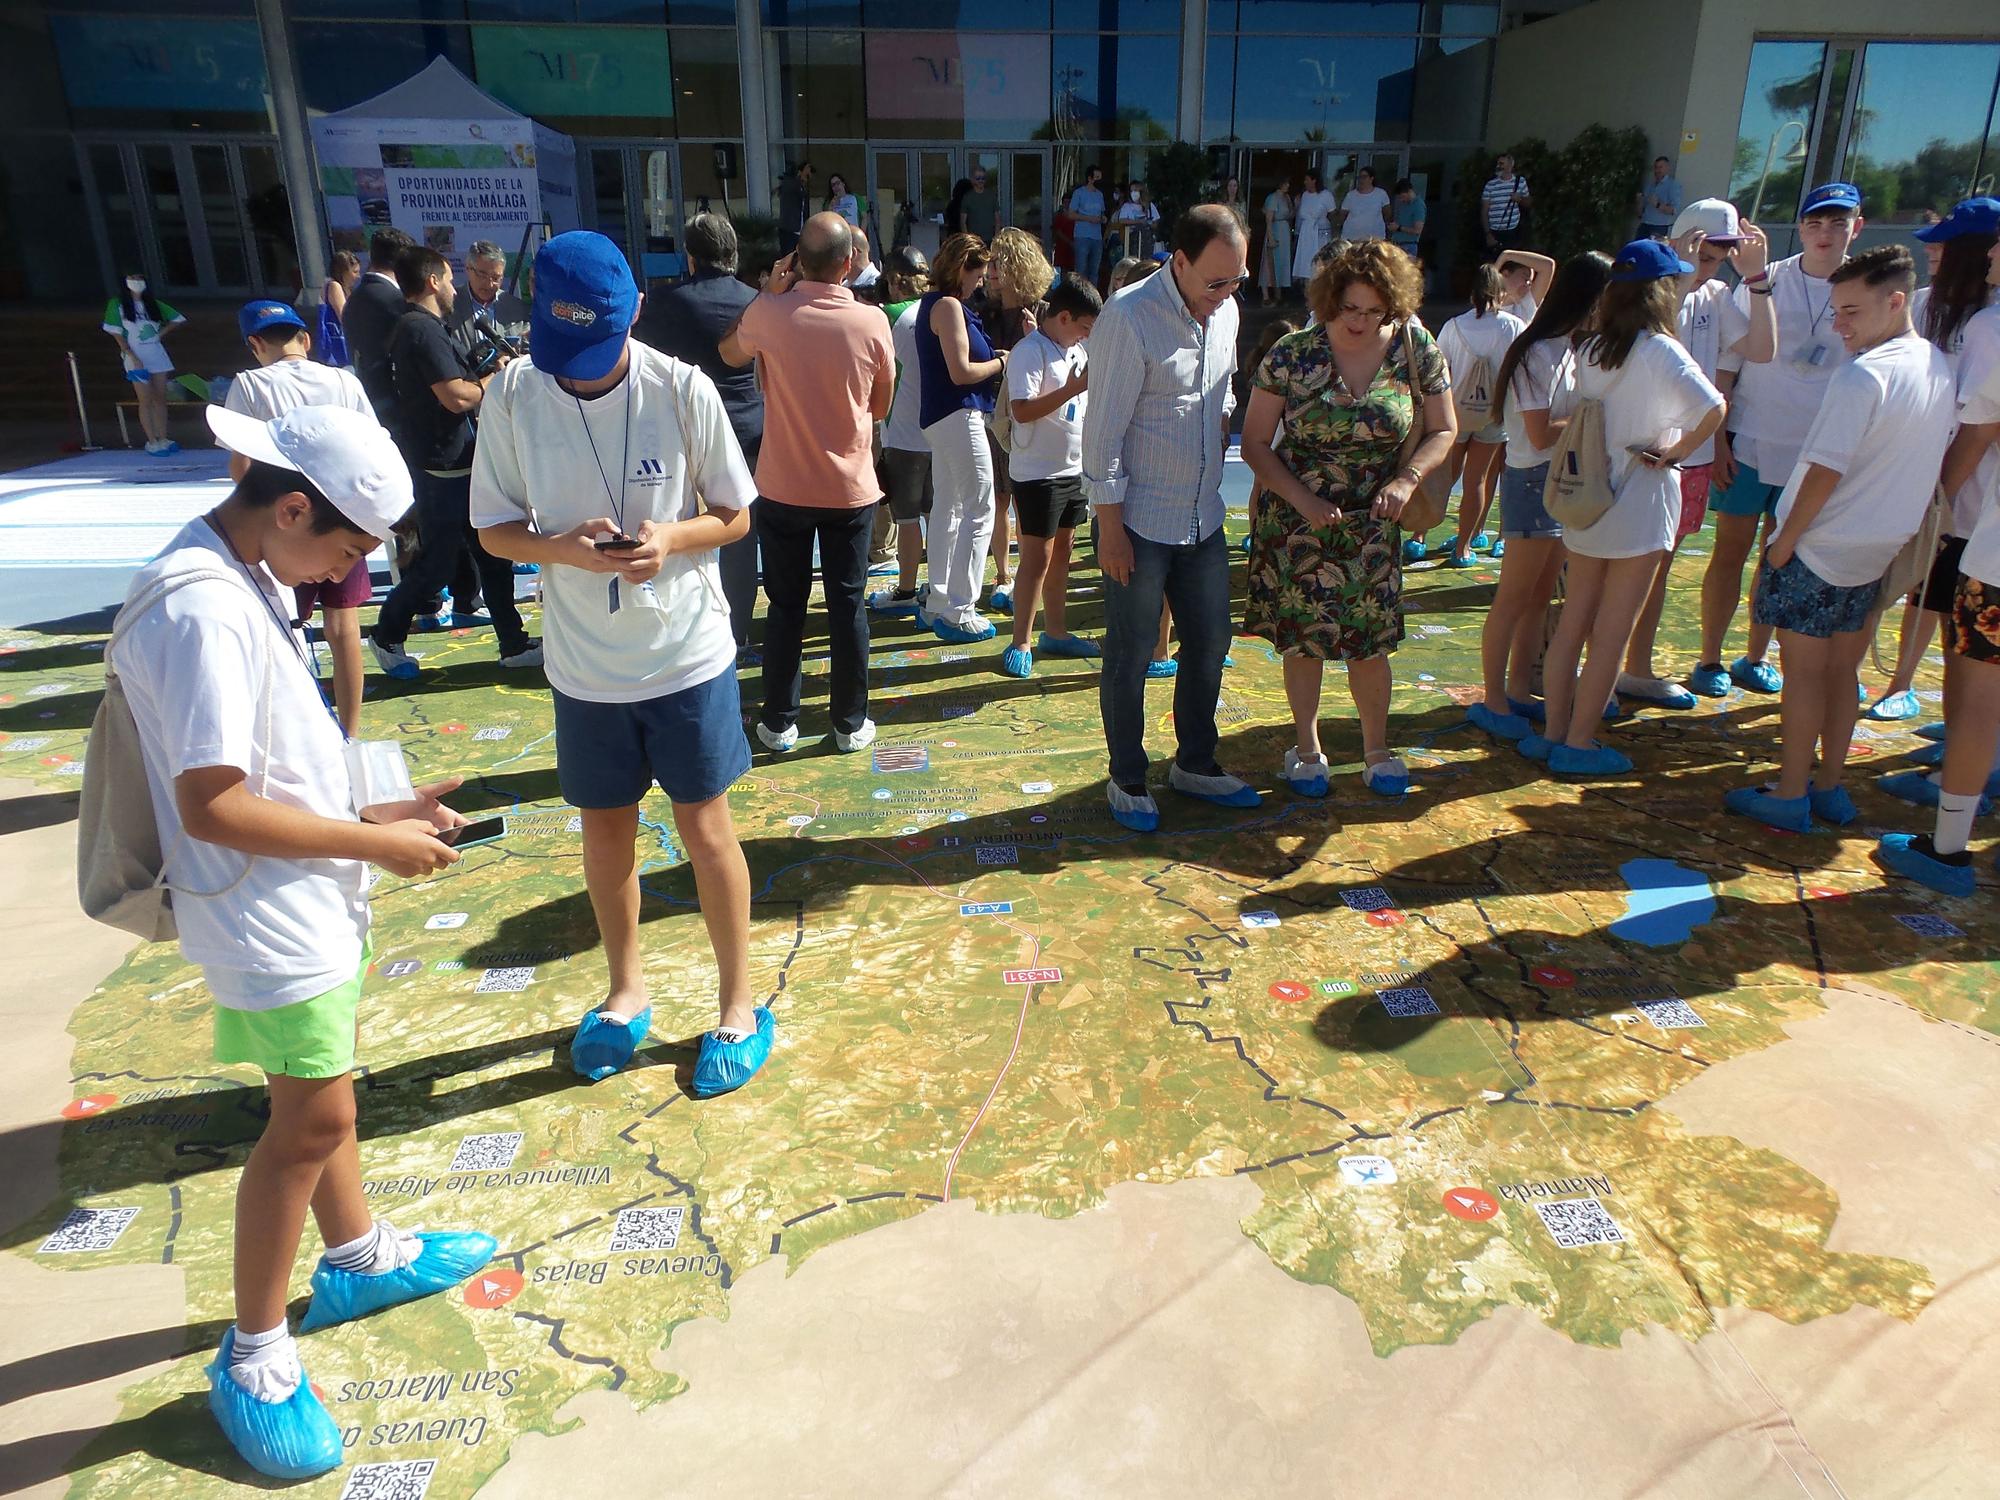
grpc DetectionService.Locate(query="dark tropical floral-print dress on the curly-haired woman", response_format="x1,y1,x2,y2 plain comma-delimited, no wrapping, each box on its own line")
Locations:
1244,328,1452,662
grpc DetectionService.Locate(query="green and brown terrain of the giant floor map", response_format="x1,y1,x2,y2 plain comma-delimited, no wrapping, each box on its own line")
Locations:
0,538,1976,1496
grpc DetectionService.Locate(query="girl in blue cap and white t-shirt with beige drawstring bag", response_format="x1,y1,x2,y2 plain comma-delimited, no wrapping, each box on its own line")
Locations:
1518,240,1724,776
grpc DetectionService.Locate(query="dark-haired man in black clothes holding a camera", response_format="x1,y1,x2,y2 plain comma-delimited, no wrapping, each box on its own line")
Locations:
374,246,542,682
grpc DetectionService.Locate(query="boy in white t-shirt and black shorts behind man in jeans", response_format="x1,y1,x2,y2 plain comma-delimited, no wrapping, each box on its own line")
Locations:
1000,276,1104,678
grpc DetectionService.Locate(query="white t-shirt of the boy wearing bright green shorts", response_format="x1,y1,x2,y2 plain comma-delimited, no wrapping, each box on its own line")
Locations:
110,520,368,1010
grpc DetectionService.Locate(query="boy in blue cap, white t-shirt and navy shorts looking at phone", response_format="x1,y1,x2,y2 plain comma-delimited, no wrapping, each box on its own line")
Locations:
472,230,776,1098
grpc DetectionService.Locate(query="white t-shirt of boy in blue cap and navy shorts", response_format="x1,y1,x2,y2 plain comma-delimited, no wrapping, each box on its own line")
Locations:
472,338,756,704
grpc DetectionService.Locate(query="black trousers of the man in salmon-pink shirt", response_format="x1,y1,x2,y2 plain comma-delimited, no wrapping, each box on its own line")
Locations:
754,496,874,734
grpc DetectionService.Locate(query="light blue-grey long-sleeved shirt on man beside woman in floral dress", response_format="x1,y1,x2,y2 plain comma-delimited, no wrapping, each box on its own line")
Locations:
1084,264,1238,546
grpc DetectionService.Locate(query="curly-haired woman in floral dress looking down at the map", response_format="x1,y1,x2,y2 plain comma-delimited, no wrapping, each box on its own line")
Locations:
1242,240,1456,796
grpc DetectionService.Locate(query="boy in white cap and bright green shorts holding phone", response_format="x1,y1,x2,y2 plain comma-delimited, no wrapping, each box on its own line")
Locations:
106,406,494,1478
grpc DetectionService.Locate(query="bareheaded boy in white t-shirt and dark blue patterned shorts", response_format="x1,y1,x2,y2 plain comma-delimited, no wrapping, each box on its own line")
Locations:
1724,244,1954,834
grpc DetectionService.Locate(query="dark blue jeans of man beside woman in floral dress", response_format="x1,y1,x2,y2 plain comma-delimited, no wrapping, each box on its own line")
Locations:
1098,526,1230,786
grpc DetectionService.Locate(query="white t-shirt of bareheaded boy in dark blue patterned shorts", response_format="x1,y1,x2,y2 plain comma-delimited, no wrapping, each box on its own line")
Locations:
1778,332,1958,588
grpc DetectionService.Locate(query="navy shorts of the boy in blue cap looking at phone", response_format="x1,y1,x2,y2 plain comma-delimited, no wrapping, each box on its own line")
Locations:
550,662,750,808
